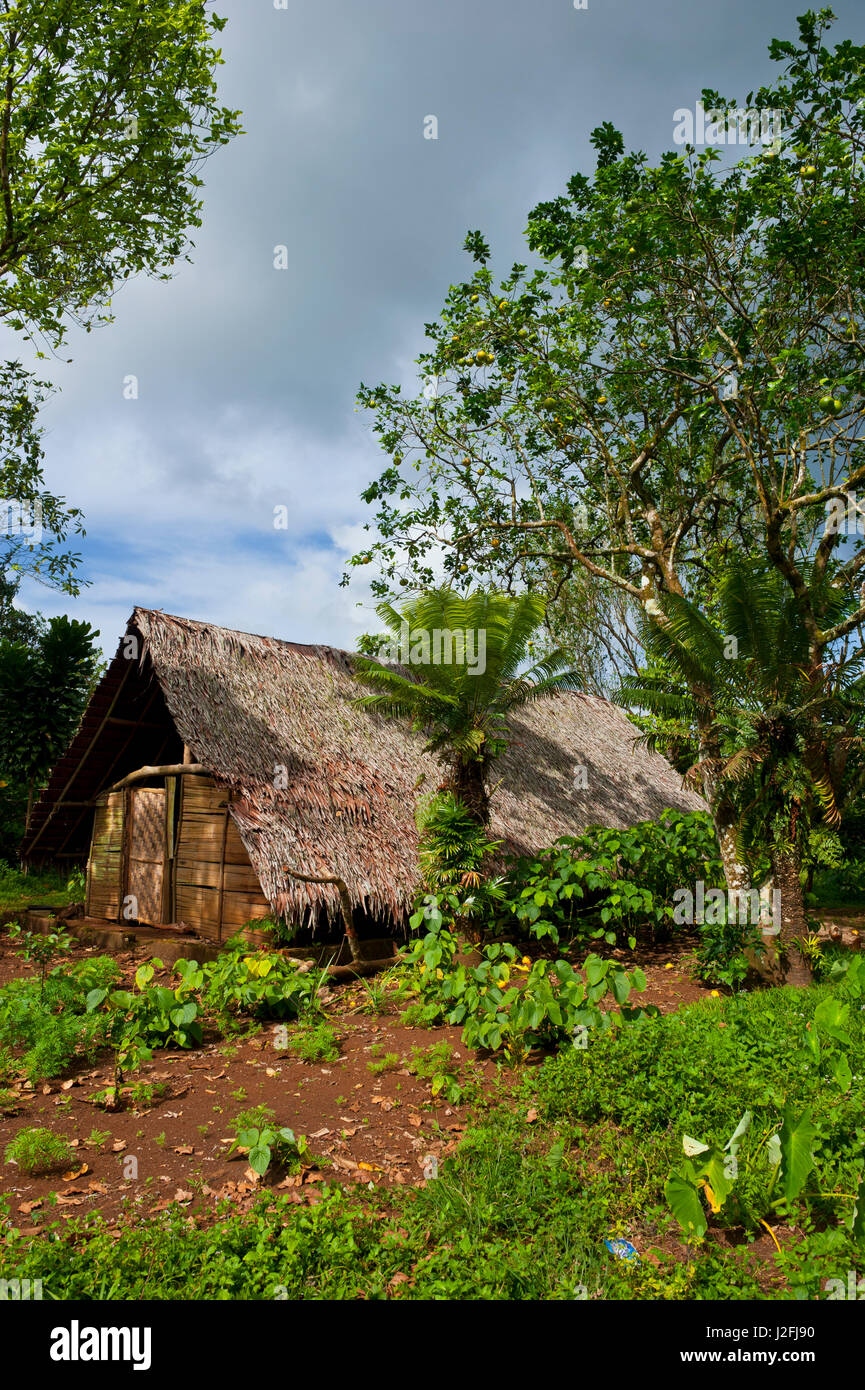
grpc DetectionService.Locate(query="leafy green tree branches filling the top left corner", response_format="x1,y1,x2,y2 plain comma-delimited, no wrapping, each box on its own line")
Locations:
0,0,238,353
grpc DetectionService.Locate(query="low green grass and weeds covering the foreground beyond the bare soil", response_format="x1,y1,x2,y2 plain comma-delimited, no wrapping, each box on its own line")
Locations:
1,967,865,1301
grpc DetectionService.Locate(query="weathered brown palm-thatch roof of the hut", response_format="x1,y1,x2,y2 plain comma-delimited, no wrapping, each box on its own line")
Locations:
24,609,702,919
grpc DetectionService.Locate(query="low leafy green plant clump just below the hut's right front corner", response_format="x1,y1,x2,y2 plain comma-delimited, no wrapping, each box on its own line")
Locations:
203,937,321,1019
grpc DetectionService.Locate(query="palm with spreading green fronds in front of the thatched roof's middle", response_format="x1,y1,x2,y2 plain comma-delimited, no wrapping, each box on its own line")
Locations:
356,588,580,826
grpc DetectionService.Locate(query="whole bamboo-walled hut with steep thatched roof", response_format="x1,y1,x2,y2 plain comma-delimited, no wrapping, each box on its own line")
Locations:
22,609,702,938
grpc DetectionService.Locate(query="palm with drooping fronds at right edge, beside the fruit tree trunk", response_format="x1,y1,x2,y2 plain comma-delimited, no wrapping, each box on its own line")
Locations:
617,560,864,969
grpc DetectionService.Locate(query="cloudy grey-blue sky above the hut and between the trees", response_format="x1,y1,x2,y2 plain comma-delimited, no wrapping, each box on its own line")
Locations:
8,0,865,653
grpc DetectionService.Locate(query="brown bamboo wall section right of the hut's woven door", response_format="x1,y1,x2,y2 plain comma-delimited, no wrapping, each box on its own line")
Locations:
174,776,270,941
